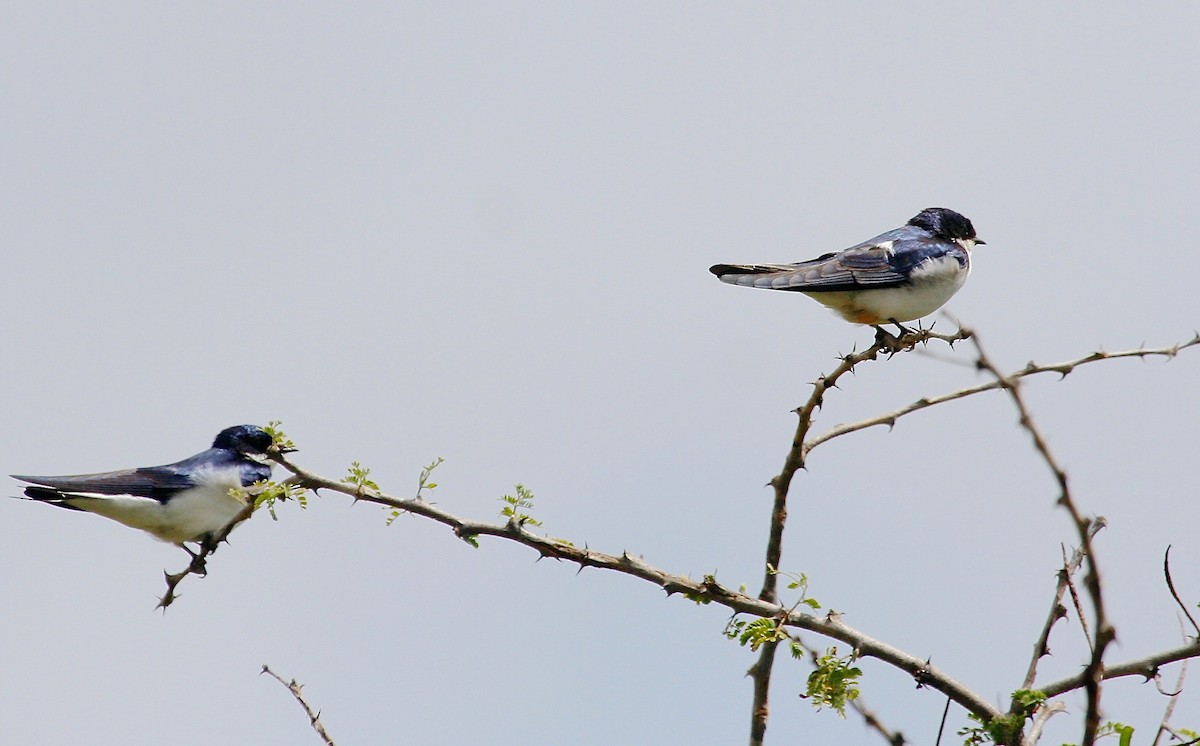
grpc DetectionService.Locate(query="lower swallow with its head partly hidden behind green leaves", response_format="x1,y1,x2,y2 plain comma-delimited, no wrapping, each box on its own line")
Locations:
12,425,288,548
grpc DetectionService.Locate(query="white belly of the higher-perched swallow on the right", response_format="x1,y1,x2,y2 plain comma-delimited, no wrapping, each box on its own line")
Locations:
805,257,971,325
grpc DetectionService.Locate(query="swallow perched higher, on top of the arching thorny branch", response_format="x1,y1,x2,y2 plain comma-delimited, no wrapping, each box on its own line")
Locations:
709,207,984,333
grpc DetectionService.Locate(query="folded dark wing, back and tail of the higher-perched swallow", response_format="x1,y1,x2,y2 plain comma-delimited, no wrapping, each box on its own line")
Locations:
709,225,947,293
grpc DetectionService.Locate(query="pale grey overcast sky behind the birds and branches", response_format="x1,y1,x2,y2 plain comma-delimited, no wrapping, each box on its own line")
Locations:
0,2,1200,746
